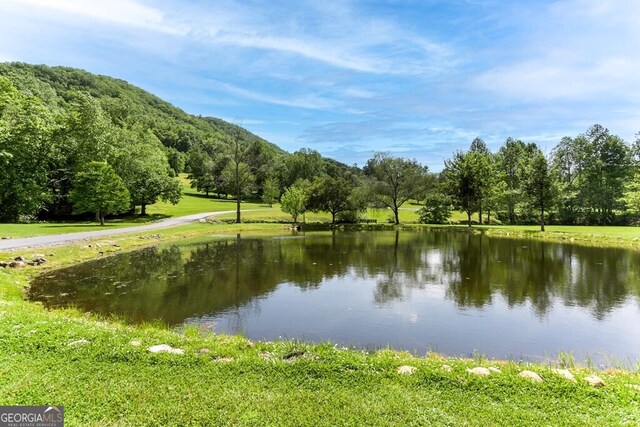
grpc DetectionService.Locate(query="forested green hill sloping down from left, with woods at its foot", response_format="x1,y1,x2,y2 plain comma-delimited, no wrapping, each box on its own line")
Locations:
0,63,349,221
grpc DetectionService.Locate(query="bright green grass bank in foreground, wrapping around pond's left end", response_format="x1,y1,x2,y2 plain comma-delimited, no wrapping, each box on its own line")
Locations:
0,224,640,426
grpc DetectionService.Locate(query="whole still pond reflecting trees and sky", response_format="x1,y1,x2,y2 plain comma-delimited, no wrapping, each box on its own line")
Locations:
29,231,640,364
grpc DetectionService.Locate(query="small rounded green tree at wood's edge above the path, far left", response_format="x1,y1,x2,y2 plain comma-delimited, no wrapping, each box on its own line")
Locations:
69,162,129,225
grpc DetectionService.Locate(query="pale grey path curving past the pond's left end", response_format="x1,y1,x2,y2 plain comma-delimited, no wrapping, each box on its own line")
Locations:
0,210,249,251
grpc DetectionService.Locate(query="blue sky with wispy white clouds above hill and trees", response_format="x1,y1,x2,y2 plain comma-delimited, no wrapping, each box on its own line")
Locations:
0,0,640,170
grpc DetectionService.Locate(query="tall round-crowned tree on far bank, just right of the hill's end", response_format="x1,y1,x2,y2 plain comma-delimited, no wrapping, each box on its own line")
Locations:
364,153,428,224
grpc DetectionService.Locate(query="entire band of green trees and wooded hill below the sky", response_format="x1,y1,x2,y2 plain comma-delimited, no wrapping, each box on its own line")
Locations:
0,63,640,228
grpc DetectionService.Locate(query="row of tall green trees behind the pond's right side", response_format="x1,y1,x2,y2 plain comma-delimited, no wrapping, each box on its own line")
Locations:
440,124,640,230
